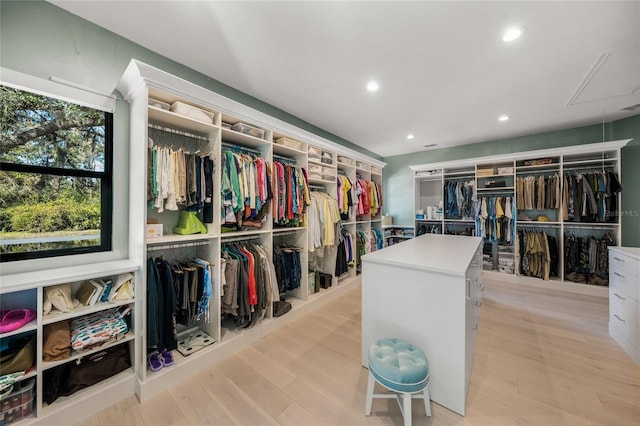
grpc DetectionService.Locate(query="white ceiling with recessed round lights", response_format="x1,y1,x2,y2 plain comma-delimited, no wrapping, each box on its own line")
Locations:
51,0,640,156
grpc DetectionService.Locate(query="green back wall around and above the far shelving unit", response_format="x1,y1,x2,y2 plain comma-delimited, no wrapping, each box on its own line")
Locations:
383,115,640,247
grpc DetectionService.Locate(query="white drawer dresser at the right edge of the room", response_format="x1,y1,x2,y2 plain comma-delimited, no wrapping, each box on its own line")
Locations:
609,247,640,364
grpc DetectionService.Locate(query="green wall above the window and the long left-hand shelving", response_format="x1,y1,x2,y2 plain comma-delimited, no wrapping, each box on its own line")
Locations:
0,0,381,159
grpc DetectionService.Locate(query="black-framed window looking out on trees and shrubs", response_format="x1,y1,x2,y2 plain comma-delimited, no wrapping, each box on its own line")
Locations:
0,83,113,262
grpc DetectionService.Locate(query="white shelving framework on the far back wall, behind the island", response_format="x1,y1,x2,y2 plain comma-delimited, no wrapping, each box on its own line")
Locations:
411,140,630,296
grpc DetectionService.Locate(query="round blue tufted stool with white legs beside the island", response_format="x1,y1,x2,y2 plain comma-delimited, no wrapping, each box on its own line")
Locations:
365,338,431,426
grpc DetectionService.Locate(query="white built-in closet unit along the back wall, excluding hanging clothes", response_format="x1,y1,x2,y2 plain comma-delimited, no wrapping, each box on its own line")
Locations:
411,139,630,296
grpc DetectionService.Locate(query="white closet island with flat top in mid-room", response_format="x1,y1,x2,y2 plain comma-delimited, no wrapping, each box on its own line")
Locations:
362,234,482,415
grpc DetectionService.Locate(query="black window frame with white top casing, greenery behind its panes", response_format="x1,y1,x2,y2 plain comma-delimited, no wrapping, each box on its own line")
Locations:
0,68,115,264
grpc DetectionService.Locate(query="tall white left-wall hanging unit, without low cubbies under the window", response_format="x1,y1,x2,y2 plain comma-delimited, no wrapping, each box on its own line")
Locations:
118,60,384,399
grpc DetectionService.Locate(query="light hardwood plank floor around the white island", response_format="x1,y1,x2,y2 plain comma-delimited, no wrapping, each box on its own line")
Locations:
78,278,640,426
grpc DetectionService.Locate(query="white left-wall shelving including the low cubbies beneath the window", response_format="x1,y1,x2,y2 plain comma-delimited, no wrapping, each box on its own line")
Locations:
0,60,385,424
